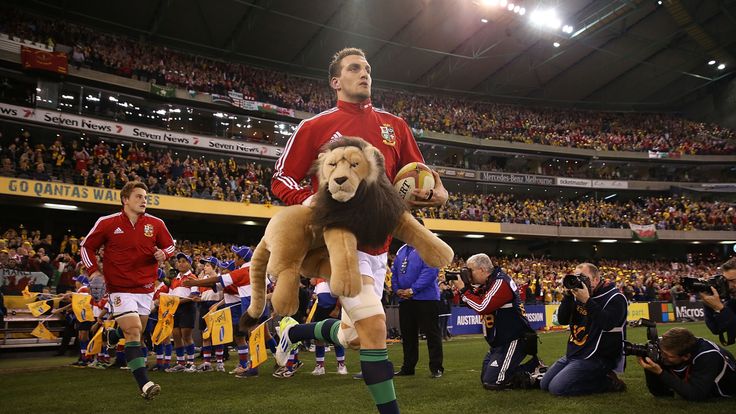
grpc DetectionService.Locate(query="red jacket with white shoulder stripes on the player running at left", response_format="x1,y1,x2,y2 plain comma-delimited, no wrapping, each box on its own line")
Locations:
80,212,175,293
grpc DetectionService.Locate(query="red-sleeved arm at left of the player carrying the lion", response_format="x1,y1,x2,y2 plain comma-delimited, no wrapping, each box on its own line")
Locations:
271,121,319,205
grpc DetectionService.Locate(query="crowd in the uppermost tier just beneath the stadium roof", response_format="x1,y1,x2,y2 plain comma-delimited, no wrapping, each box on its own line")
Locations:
0,9,736,154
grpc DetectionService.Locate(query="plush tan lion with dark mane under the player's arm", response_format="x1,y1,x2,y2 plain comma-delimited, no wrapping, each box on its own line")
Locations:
240,137,453,329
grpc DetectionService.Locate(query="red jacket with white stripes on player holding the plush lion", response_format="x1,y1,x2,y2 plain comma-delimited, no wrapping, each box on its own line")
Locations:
271,100,424,254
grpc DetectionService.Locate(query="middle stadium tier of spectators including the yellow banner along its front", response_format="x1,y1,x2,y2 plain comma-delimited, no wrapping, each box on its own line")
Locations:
0,123,736,236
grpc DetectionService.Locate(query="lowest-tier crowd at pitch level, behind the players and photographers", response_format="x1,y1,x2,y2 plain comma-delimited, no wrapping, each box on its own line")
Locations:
0,224,718,303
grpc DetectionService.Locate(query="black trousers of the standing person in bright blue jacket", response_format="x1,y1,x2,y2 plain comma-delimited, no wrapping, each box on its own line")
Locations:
399,300,445,374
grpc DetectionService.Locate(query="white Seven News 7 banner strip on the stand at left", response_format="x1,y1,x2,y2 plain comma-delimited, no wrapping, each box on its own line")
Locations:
0,103,283,158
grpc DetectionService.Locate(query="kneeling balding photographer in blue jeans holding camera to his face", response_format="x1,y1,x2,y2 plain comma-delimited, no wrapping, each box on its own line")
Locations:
541,263,627,396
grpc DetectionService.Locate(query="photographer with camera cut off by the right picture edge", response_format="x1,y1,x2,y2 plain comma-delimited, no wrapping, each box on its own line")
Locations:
700,257,736,345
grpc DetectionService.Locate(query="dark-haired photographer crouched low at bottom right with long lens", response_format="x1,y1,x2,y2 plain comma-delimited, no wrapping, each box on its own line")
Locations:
638,328,736,401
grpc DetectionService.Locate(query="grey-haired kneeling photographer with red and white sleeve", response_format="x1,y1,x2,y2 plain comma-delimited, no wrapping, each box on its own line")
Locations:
445,253,544,391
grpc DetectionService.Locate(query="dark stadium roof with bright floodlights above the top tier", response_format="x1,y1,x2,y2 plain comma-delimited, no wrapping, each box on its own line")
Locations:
16,0,736,109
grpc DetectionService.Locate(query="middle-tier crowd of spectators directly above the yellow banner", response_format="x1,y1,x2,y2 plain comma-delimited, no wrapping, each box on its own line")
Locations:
0,131,736,231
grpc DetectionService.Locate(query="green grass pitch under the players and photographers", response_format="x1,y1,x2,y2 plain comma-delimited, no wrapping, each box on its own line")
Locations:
0,323,736,414
